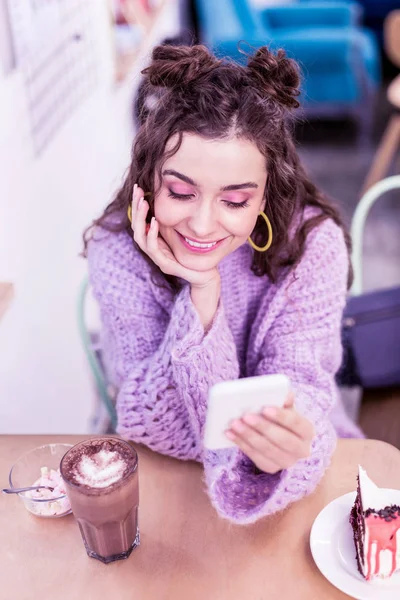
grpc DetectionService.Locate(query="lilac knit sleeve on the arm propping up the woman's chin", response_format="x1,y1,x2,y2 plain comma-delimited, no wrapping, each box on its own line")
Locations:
88,229,239,460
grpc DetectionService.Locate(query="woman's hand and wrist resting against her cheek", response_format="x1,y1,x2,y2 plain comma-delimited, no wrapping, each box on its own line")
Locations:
132,184,220,329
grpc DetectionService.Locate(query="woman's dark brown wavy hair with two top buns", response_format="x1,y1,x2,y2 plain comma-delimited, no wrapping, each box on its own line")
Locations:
84,45,352,288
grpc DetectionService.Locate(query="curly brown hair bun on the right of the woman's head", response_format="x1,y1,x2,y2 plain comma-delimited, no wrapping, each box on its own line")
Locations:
247,46,300,109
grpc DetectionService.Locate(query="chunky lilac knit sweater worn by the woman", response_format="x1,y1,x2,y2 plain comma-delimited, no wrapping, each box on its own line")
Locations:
88,220,363,524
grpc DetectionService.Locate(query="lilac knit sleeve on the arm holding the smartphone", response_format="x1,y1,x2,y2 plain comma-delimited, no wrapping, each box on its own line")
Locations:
205,221,354,524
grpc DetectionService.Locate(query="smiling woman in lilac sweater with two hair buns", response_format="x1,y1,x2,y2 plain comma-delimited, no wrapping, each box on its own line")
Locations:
87,46,362,523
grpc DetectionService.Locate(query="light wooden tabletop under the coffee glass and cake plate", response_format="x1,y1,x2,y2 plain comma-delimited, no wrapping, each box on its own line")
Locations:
0,436,400,600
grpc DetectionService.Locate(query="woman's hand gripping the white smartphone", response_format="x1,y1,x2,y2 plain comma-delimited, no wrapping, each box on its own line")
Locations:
226,393,315,473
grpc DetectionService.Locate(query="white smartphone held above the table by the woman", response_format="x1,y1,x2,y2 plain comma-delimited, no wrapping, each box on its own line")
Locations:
204,375,290,450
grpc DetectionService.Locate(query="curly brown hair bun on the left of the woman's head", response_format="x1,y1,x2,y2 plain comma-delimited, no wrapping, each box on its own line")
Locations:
142,45,220,88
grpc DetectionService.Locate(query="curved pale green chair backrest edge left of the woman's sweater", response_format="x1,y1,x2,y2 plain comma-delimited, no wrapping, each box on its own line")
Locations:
77,277,117,431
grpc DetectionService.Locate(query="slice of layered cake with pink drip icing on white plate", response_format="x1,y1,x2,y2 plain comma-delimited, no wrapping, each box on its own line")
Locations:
350,466,400,580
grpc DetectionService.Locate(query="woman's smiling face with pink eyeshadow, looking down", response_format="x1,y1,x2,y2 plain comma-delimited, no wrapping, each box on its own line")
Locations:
154,134,267,271
